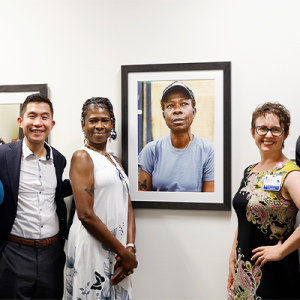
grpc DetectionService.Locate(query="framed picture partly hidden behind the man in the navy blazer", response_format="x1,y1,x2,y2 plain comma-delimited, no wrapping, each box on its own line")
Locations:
0,84,48,143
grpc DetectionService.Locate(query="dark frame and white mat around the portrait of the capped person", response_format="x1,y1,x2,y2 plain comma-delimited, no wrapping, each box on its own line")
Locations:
122,62,231,210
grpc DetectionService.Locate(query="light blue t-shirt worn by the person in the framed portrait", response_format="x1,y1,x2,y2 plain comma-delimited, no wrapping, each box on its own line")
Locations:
138,135,215,192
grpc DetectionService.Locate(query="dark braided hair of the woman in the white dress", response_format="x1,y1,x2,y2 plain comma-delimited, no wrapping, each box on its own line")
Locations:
81,97,117,140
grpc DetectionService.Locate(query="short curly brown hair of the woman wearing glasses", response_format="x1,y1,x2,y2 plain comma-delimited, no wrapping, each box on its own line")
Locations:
251,102,291,148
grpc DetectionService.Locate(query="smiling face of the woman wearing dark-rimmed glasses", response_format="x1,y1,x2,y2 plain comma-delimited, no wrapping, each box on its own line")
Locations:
251,113,288,153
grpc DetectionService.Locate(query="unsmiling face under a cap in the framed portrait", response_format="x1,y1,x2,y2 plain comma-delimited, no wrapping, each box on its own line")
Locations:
162,92,196,133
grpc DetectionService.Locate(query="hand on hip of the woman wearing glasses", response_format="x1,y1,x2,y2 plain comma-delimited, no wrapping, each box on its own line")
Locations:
251,237,284,267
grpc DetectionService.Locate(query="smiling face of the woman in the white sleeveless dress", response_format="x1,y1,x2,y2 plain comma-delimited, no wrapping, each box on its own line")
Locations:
81,106,112,147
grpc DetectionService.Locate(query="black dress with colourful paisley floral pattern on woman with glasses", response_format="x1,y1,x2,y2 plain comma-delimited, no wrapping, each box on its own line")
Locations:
228,161,300,300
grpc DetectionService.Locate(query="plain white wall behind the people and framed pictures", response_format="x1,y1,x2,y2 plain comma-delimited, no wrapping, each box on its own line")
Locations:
0,0,300,300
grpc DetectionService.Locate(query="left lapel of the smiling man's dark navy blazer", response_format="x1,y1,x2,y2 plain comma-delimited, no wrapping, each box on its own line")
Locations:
6,140,23,203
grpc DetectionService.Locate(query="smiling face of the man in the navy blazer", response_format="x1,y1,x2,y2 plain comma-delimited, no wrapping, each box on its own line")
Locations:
18,102,55,144
